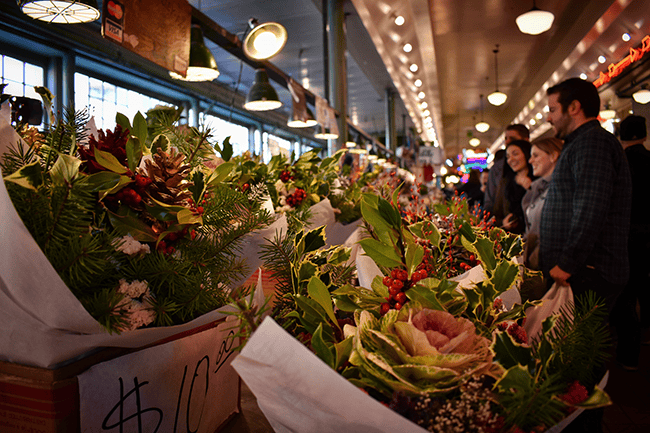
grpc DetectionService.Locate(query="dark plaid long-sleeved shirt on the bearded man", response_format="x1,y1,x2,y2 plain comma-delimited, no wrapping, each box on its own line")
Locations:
540,120,632,284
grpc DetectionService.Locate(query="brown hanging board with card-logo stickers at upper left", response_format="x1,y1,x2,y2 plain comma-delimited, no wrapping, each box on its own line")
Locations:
102,0,192,76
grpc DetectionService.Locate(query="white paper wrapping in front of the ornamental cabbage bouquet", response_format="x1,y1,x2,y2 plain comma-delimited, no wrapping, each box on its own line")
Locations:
232,318,426,433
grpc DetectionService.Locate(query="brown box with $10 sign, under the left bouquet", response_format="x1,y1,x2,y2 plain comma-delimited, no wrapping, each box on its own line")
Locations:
0,319,240,433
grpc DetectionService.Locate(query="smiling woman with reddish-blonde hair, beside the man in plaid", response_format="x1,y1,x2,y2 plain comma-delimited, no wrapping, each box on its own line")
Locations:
521,137,564,270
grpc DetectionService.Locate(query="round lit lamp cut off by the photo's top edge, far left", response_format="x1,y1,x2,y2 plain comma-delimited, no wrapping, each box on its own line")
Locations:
17,0,100,24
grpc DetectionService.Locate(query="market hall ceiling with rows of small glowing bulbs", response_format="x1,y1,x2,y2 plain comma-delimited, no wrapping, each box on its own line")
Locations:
189,0,650,157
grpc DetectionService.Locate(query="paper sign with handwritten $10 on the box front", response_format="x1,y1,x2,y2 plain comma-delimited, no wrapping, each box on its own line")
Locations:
79,321,239,433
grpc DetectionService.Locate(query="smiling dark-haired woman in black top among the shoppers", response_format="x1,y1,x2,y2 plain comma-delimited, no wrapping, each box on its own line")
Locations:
492,140,535,234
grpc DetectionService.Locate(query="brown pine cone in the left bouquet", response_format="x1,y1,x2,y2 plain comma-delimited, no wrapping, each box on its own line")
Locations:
145,149,192,206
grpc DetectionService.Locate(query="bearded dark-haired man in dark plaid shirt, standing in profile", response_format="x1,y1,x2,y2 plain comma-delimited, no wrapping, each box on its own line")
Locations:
540,78,632,312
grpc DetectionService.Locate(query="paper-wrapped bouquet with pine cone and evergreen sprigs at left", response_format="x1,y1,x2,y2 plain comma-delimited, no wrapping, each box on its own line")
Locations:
0,89,272,365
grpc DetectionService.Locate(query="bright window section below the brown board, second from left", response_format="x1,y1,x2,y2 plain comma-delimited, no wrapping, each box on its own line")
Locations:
74,72,171,129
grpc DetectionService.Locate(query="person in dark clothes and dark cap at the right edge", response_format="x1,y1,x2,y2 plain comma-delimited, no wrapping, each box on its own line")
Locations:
612,115,650,370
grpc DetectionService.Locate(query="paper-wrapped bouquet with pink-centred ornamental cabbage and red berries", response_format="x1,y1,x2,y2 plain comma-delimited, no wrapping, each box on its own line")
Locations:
233,194,609,432
